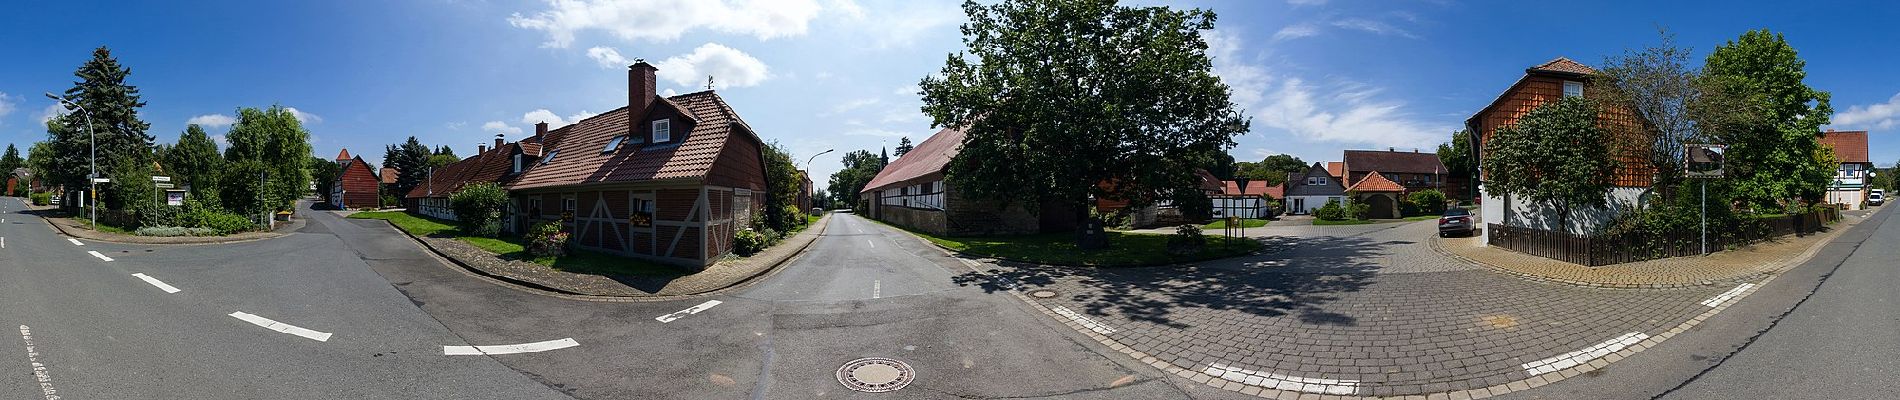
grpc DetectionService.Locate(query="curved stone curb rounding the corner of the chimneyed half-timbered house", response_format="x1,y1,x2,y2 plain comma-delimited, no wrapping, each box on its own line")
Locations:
382,214,830,303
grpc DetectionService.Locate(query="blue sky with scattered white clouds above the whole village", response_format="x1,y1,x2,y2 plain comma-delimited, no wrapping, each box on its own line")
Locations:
0,0,1900,184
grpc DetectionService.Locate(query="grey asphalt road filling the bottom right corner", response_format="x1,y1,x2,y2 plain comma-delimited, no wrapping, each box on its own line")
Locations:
1511,207,1900,400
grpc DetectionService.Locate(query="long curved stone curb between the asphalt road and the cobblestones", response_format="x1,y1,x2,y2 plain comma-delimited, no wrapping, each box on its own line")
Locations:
899,212,1847,400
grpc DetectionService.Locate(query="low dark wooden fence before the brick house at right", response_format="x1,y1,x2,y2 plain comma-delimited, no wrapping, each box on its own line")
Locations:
1486,209,1841,267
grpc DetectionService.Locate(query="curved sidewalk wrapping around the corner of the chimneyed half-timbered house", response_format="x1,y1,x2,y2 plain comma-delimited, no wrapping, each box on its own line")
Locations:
390,214,830,300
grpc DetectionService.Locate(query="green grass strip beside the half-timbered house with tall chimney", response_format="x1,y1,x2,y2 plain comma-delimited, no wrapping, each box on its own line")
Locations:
350,210,686,277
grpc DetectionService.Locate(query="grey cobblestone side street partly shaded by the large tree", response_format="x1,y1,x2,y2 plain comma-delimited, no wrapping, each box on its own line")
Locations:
958,222,1752,398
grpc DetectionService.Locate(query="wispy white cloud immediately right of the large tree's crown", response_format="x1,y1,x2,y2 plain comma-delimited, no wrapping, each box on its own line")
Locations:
1207,32,1455,148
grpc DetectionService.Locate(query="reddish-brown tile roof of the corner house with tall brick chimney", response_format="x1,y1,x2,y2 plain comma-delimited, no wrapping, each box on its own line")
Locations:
509,91,758,190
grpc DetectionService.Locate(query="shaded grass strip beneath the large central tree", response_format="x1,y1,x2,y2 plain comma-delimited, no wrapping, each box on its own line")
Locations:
880,222,1260,267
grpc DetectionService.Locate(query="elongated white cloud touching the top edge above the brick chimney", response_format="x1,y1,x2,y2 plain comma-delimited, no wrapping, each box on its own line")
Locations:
507,0,821,47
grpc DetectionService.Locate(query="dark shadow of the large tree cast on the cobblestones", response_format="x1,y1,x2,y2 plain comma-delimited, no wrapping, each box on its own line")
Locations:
952,237,1387,328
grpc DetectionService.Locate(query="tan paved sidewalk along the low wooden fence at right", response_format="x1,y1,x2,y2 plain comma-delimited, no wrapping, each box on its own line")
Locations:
1431,212,1868,288
